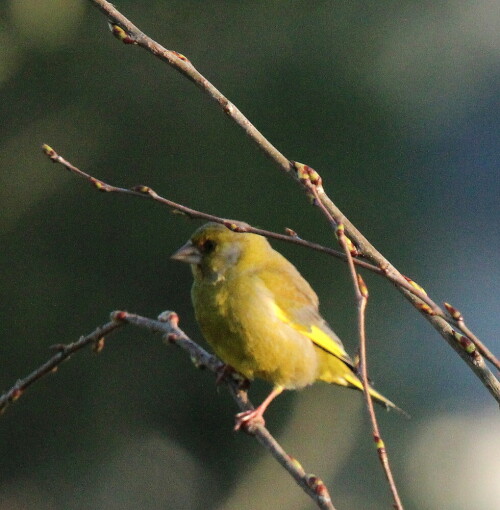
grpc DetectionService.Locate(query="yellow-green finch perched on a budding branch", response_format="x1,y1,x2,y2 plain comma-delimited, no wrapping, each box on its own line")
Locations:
172,223,397,430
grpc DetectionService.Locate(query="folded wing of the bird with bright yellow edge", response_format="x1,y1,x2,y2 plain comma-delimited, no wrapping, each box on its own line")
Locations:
259,259,353,368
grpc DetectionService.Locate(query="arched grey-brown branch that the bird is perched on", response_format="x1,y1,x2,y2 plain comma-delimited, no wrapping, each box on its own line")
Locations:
0,311,335,510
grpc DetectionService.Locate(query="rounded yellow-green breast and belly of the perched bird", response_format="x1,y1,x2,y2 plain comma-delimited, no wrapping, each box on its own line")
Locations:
192,279,319,389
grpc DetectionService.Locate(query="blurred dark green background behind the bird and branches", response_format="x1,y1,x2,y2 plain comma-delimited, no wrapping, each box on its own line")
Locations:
0,0,500,510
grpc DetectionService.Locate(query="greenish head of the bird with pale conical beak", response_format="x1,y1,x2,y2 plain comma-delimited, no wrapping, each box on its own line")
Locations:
171,223,271,281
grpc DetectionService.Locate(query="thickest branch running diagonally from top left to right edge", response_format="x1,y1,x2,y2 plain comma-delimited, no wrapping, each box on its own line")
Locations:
83,0,500,403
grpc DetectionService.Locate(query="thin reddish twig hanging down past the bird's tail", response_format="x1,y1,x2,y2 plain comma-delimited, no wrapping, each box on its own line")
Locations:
336,224,403,510
